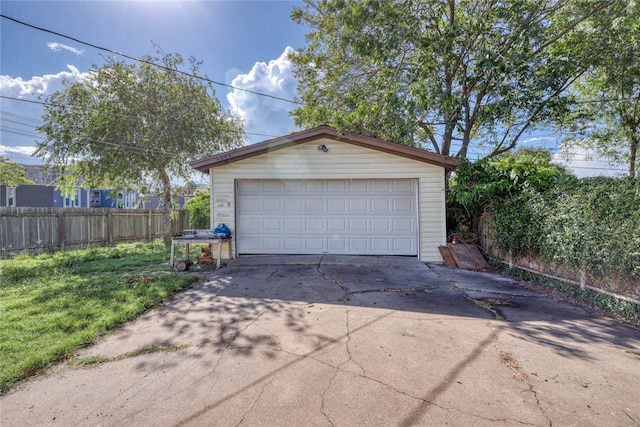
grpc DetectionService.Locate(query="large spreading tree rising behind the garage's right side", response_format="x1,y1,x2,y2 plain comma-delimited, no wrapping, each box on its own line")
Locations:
292,0,614,157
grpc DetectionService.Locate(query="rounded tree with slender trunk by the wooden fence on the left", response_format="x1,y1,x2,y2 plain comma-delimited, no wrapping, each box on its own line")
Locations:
36,53,244,238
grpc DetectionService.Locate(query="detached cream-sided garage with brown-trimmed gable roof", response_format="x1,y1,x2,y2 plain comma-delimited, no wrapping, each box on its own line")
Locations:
191,126,459,262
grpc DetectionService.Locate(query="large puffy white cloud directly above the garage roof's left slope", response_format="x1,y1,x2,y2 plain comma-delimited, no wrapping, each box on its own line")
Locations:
227,47,298,142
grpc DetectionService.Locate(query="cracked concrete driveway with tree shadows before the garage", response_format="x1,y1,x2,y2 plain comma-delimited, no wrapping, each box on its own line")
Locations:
0,256,640,427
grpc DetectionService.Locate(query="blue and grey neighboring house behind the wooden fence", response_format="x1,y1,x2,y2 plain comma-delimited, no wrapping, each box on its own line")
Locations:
0,184,89,208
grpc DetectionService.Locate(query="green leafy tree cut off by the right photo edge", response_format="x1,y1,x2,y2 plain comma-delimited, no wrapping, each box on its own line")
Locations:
560,2,640,177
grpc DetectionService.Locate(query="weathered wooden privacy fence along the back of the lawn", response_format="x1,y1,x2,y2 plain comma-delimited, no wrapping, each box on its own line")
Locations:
0,207,188,258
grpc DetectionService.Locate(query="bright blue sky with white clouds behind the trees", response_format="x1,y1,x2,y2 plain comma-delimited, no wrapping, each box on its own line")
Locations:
0,0,624,175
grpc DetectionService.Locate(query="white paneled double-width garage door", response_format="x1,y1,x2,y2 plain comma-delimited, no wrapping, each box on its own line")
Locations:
236,179,418,255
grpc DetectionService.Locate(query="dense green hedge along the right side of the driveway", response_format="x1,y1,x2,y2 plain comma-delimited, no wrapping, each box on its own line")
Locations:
493,177,640,279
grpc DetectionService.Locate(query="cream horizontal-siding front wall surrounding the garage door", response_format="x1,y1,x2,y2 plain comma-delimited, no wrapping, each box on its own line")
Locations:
210,139,446,263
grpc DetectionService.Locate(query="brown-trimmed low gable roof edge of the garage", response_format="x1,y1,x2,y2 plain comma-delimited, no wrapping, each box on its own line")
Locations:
191,126,462,173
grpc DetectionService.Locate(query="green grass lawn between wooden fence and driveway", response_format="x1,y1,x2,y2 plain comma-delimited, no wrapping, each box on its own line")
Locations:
0,242,198,393
